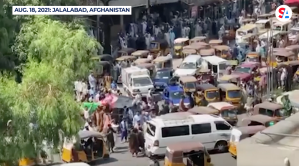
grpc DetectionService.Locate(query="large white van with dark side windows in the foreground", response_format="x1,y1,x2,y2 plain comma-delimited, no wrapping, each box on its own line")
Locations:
144,112,232,156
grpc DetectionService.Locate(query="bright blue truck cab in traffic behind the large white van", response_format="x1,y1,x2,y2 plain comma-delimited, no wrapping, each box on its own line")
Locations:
162,85,190,106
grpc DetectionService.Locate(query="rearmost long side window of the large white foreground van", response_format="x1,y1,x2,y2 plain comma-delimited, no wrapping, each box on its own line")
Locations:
162,125,190,138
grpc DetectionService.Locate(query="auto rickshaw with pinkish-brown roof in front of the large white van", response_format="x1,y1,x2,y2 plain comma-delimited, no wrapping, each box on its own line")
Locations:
164,141,213,166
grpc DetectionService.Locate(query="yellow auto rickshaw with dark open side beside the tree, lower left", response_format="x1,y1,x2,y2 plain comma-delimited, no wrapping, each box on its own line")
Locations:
61,131,109,163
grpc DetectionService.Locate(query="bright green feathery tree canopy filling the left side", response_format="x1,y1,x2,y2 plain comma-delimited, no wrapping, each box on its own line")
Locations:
0,3,102,163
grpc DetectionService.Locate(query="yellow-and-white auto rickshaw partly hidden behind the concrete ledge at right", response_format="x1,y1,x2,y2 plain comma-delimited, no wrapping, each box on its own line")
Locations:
228,125,266,158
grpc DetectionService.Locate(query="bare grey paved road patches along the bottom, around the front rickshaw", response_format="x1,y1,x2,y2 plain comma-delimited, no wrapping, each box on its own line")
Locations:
96,140,237,166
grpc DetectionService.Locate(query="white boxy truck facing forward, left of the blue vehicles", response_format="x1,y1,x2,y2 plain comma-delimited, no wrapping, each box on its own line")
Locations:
121,66,154,96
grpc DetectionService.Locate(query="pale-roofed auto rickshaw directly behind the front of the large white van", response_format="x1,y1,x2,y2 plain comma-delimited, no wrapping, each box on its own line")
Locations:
207,102,238,125
